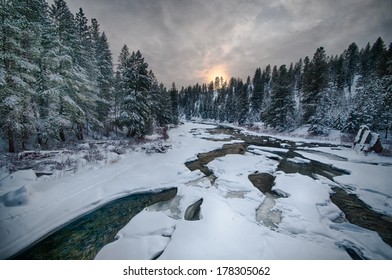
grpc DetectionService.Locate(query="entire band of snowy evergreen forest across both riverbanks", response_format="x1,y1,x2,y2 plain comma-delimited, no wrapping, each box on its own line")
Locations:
0,0,392,152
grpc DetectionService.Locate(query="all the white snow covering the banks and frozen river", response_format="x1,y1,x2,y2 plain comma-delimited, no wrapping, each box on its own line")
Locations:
0,123,392,259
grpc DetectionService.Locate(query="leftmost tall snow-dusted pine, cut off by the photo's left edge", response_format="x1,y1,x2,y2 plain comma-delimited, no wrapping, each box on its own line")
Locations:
0,1,41,152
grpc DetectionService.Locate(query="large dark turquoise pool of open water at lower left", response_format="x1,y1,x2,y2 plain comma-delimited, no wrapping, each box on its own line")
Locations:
11,188,177,260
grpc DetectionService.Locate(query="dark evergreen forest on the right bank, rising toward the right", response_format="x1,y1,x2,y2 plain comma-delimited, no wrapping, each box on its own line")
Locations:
180,38,392,138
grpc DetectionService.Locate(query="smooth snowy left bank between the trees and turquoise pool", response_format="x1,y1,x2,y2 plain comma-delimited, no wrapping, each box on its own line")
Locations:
0,124,227,258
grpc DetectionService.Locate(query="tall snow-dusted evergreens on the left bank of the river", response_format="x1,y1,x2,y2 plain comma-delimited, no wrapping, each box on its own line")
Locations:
0,0,178,152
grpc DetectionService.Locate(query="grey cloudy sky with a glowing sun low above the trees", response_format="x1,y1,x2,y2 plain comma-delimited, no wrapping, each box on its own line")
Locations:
53,0,392,86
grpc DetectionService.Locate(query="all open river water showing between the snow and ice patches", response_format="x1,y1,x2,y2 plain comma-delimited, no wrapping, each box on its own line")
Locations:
12,124,392,259
